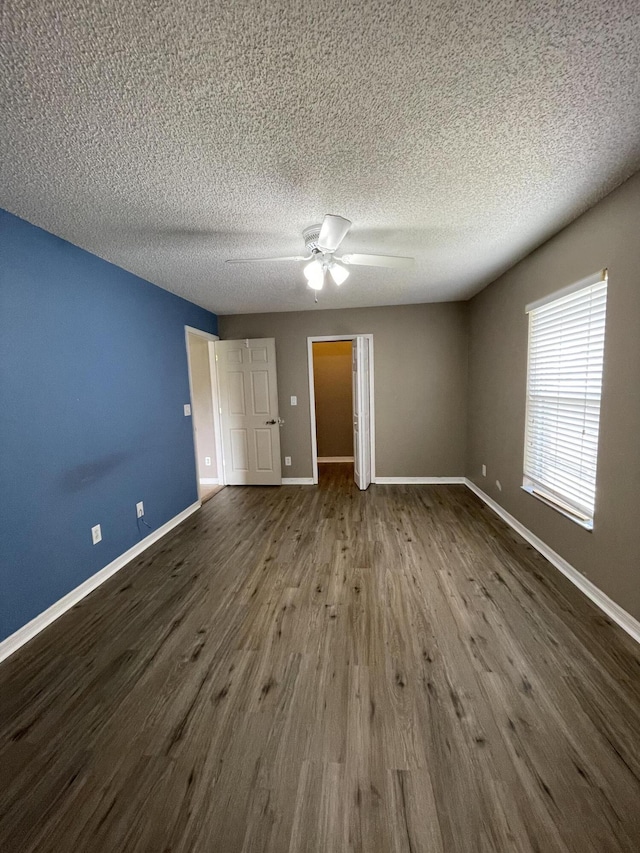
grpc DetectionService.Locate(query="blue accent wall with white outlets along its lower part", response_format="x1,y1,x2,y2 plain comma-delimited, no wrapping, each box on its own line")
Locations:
0,210,217,640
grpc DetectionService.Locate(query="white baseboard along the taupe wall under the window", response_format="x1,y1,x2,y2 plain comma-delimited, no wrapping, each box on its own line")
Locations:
465,479,640,643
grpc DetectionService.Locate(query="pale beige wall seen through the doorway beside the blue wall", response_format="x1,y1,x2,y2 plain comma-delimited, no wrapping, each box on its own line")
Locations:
188,334,218,479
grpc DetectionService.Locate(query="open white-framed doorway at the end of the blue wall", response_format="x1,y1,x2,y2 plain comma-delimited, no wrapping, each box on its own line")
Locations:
185,326,224,503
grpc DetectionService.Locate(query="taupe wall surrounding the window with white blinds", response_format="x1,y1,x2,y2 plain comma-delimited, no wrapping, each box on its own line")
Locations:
468,174,640,618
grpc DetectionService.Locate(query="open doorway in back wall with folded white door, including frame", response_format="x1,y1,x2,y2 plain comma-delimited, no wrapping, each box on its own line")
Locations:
307,335,375,489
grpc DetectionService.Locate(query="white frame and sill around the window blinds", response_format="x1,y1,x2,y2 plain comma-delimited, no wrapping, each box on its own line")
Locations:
521,269,608,531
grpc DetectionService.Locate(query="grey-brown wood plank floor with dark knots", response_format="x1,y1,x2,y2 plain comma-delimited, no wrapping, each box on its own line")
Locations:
0,465,640,853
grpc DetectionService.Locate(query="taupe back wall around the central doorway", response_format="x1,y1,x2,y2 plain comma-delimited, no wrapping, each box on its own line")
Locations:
219,302,467,477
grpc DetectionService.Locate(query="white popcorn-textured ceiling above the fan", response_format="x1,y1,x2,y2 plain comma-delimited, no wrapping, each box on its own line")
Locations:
0,0,640,314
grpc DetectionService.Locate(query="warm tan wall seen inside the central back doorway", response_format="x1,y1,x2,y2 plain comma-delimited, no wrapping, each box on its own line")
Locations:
313,341,353,456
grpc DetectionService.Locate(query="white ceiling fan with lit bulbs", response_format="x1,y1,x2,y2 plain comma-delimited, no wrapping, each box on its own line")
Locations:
227,213,414,290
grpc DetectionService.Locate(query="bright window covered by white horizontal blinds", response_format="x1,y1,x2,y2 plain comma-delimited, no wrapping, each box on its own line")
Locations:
523,270,607,529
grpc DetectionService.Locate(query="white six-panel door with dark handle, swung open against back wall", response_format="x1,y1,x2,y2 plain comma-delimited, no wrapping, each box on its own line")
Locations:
215,338,282,486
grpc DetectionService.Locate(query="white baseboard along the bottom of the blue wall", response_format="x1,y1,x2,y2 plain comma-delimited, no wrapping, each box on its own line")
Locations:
0,501,200,661
